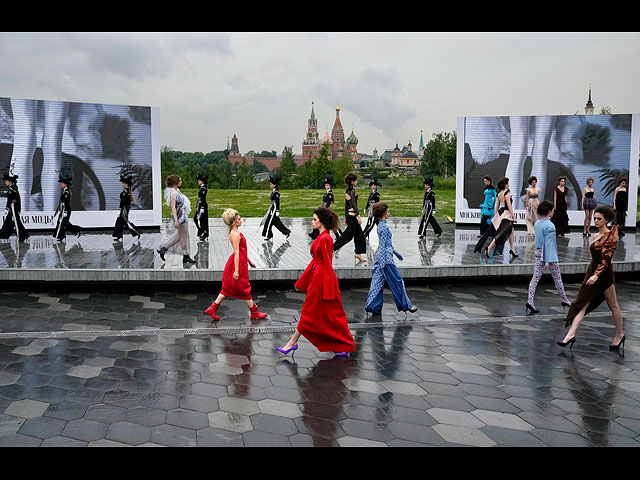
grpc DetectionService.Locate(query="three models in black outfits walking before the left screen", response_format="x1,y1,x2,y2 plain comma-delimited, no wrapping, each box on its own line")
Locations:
0,169,140,242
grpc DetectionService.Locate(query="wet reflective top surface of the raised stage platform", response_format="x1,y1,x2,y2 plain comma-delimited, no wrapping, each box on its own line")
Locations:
0,218,640,271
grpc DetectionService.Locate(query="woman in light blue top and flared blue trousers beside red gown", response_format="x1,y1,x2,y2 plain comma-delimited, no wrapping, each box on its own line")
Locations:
364,202,418,313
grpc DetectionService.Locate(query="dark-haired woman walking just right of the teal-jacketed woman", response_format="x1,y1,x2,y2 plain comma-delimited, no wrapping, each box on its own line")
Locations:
473,177,518,258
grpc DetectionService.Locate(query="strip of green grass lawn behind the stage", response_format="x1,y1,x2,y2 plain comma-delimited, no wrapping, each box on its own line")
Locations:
162,187,456,218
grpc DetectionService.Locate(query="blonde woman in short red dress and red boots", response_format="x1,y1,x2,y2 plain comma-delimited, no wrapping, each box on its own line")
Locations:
205,208,267,320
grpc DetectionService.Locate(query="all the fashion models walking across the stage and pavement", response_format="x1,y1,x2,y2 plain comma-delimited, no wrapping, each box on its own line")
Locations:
0,167,628,356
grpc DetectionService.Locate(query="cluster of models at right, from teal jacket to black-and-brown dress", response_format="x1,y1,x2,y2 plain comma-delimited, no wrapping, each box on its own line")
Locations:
474,176,628,350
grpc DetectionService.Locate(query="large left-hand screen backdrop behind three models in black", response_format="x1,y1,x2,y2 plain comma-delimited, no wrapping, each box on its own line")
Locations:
0,97,162,229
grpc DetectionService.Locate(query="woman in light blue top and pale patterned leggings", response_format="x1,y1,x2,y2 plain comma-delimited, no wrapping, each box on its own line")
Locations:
525,200,571,313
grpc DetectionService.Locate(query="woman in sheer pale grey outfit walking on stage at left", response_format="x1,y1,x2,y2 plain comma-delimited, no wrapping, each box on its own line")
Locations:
157,174,196,265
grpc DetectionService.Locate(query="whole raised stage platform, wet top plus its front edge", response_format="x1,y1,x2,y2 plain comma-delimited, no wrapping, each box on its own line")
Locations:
0,218,640,283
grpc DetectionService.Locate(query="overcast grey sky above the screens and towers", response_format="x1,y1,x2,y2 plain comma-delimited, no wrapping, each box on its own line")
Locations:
0,32,640,153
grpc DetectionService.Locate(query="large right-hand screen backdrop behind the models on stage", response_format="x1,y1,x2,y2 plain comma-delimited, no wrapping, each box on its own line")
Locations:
456,114,640,226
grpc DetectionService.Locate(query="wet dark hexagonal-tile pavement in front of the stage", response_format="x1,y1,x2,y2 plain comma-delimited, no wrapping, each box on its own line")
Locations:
0,275,640,446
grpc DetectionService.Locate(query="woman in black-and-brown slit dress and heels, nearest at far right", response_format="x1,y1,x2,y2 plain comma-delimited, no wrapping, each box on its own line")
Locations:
558,205,626,350
